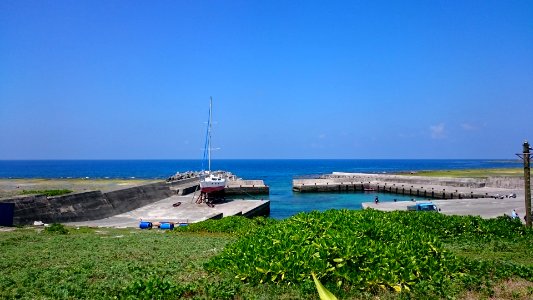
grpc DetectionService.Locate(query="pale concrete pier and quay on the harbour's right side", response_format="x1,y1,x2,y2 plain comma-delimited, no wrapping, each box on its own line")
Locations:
293,172,525,218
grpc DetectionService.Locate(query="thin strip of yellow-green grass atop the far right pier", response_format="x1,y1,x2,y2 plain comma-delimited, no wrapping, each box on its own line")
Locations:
405,168,524,178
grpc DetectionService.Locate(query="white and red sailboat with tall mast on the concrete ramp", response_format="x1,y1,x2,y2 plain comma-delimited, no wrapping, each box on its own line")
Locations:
200,97,226,194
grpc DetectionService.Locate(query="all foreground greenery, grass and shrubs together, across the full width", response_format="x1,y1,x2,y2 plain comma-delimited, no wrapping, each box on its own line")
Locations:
0,210,533,299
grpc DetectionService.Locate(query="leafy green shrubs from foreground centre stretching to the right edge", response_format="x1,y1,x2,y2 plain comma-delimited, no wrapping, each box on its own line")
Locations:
206,210,533,297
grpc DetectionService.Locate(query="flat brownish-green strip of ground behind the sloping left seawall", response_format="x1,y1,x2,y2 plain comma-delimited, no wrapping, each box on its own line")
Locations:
0,179,160,198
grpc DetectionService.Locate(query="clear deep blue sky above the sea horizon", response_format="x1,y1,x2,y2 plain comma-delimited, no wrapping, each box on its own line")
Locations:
0,0,533,159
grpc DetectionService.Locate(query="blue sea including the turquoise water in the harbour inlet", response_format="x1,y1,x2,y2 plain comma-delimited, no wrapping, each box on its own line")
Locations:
0,159,521,219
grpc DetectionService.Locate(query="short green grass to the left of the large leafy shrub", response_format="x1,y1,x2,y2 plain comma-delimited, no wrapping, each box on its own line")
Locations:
0,228,233,299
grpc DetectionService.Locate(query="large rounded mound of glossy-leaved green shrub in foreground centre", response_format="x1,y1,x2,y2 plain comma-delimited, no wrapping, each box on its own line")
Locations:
206,210,459,291
